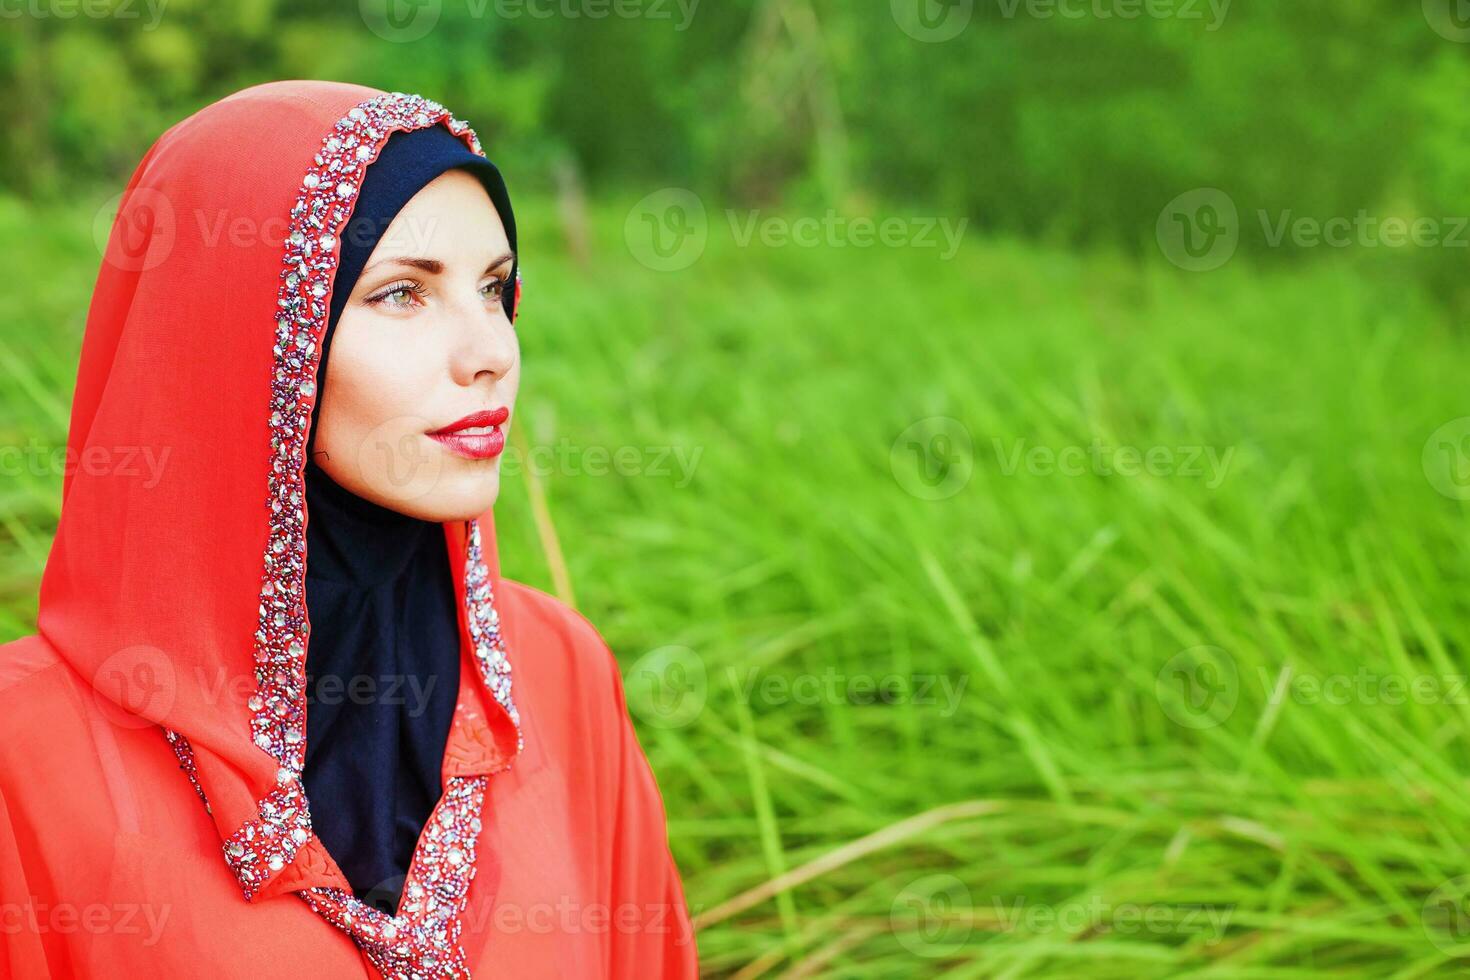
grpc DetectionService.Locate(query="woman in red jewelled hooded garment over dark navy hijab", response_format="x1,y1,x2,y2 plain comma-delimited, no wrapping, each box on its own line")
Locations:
0,82,697,979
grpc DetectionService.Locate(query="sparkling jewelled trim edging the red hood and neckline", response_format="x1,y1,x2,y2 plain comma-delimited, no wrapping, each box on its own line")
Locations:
165,93,525,979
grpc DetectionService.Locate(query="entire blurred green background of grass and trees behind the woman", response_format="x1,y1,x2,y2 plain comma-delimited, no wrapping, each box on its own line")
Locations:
0,0,1470,980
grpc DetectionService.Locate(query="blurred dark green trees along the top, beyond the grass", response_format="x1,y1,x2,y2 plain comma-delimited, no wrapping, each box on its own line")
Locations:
0,0,1470,283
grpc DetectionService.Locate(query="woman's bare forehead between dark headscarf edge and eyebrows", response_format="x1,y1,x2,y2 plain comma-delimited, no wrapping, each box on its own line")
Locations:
372,170,510,266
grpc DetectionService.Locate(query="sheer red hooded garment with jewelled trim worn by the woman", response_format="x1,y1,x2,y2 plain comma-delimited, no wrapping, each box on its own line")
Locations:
0,82,697,980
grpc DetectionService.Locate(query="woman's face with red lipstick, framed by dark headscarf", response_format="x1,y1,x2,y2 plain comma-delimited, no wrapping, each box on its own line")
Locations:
312,170,520,522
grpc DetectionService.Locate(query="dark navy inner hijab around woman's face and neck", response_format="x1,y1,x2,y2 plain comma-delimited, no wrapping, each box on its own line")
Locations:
303,126,516,914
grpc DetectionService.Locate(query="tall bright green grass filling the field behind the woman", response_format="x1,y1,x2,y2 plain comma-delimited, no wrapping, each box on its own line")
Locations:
0,194,1470,980
